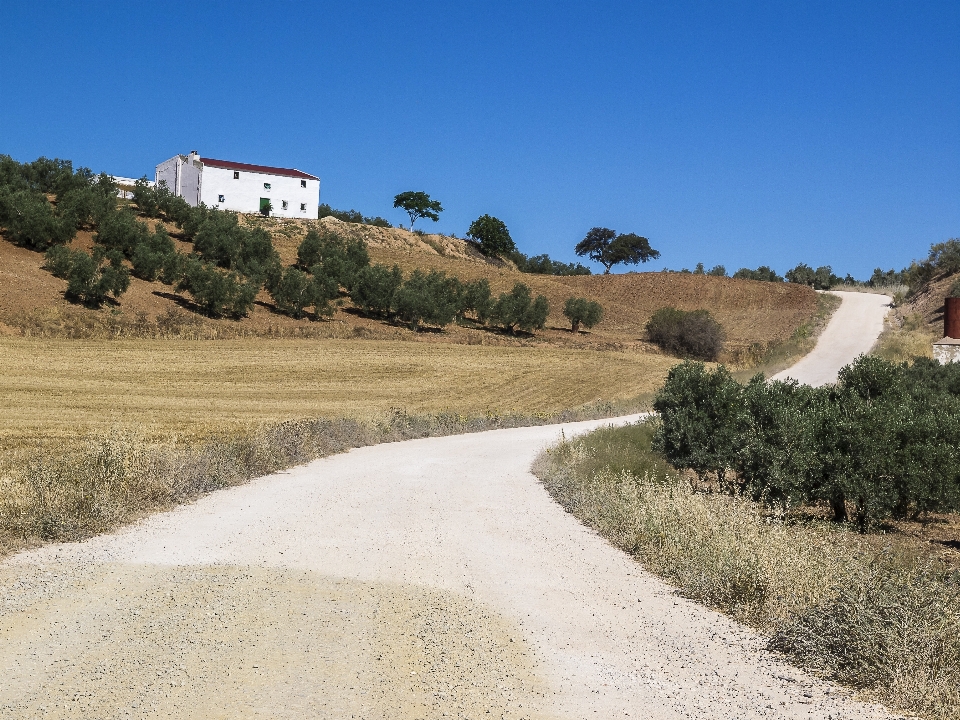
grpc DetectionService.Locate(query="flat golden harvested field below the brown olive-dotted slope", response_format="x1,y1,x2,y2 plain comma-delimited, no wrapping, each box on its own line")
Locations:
0,337,676,446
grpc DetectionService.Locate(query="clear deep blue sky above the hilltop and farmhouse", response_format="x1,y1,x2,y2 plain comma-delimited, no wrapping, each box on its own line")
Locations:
0,0,960,277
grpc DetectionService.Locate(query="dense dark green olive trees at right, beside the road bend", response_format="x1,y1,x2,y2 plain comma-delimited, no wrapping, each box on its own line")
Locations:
654,357,960,529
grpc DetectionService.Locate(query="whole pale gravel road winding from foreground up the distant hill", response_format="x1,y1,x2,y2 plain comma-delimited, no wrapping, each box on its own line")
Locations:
0,293,887,719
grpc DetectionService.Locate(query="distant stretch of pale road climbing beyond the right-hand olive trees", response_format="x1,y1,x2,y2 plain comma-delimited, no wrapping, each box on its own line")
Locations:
772,291,890,386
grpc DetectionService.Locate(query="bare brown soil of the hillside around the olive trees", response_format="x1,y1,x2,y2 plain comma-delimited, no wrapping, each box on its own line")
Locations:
0,211,817,361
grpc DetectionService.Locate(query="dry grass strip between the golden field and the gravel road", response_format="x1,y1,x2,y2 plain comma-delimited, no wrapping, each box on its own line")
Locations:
0,397,649,556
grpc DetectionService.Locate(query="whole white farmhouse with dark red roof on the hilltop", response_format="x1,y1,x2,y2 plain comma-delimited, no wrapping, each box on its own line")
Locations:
156,150,320,218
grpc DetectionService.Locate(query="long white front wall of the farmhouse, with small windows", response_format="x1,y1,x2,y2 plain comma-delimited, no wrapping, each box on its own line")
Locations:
200,165,320,220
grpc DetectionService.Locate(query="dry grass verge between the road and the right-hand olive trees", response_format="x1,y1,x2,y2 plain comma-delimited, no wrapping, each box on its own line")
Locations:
534,423,960,720
